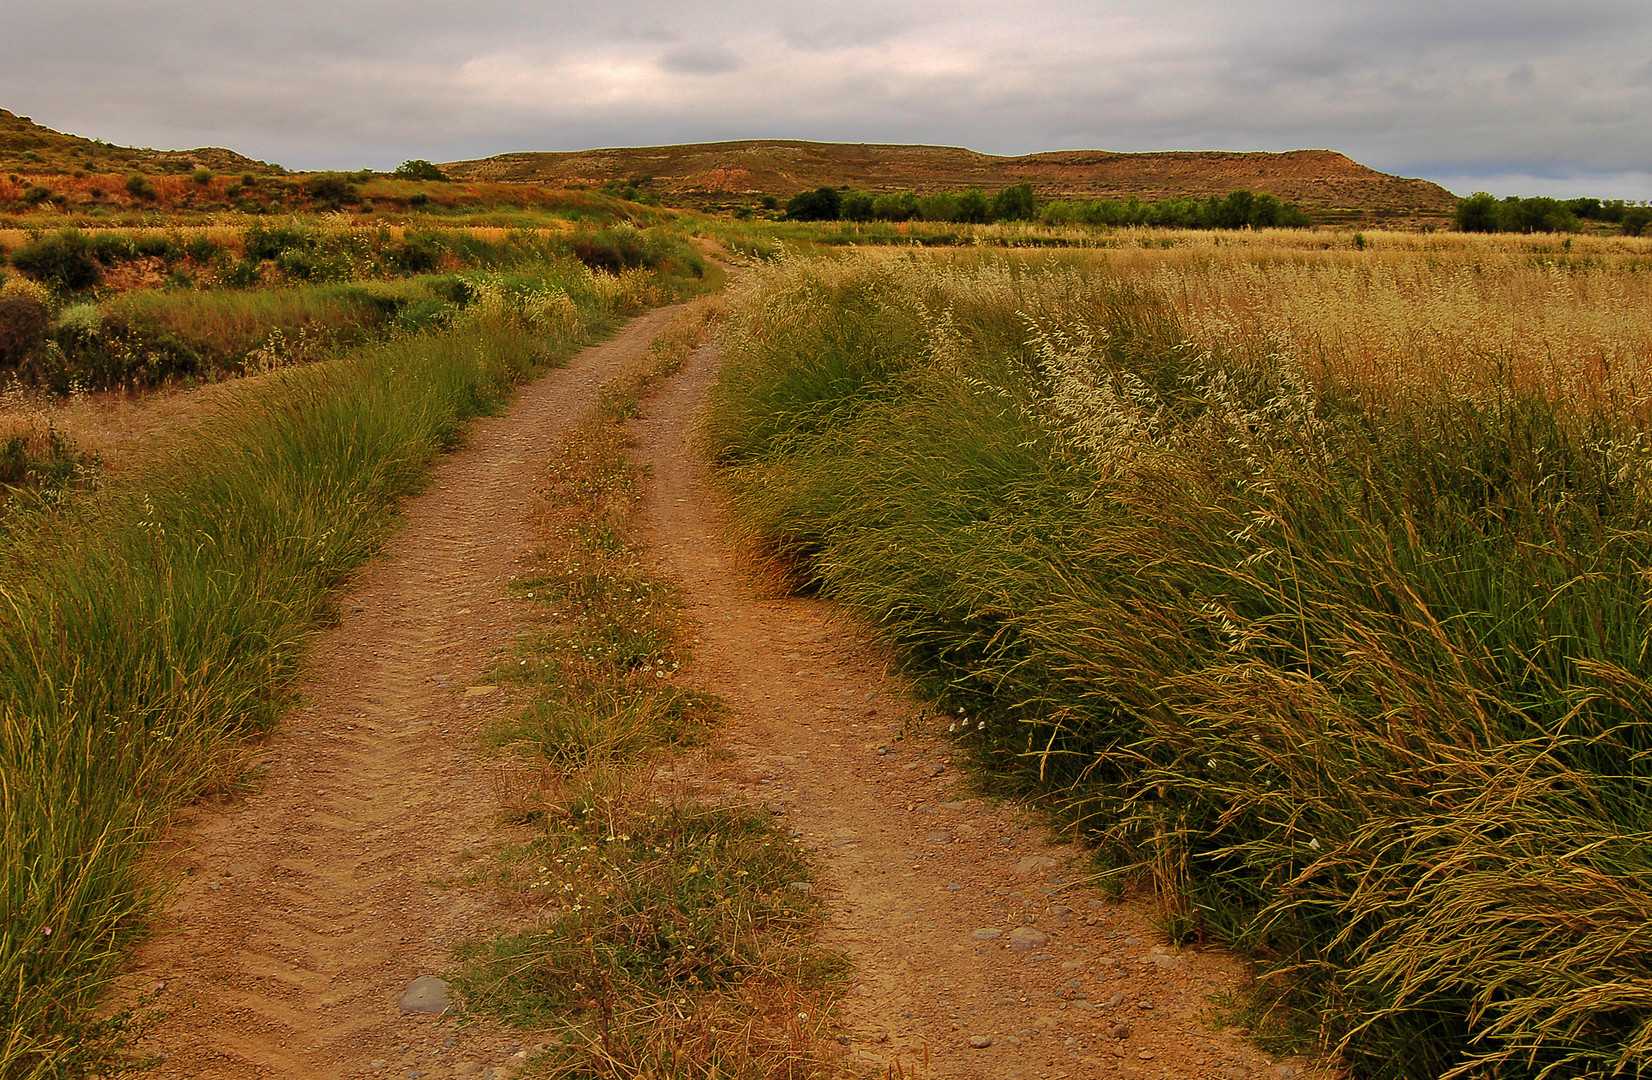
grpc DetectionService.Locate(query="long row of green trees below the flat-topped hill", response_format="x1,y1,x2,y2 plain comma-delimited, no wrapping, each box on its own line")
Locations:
786,183,1312,230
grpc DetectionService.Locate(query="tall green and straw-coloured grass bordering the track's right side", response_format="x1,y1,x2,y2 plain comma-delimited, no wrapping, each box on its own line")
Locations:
709,248,1652,1078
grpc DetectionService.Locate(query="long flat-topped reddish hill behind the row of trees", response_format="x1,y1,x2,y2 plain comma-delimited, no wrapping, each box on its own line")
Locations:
443,140,1457,216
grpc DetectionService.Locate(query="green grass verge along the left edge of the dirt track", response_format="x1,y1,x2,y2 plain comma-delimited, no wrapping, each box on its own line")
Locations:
0,257,703,1080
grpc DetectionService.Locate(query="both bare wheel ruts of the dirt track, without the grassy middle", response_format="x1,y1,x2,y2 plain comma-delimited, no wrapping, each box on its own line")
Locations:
135,298,1328,1080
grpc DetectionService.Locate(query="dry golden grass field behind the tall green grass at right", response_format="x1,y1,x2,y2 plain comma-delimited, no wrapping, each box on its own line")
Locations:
1095,230,1652,414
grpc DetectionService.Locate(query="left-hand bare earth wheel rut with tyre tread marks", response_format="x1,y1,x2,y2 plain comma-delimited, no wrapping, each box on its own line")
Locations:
132,309,690,1080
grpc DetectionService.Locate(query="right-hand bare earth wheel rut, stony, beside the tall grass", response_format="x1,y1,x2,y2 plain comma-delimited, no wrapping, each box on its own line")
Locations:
634,347,1323,1080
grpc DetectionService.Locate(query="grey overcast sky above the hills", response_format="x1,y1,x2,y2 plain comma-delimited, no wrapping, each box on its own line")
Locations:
0,0,1652,198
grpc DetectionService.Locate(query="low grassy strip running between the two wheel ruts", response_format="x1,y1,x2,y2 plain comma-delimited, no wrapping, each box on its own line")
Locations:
458,303,843,1080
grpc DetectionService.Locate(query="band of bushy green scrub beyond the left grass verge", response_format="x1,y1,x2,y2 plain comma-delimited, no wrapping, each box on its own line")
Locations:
0,218,705,395
